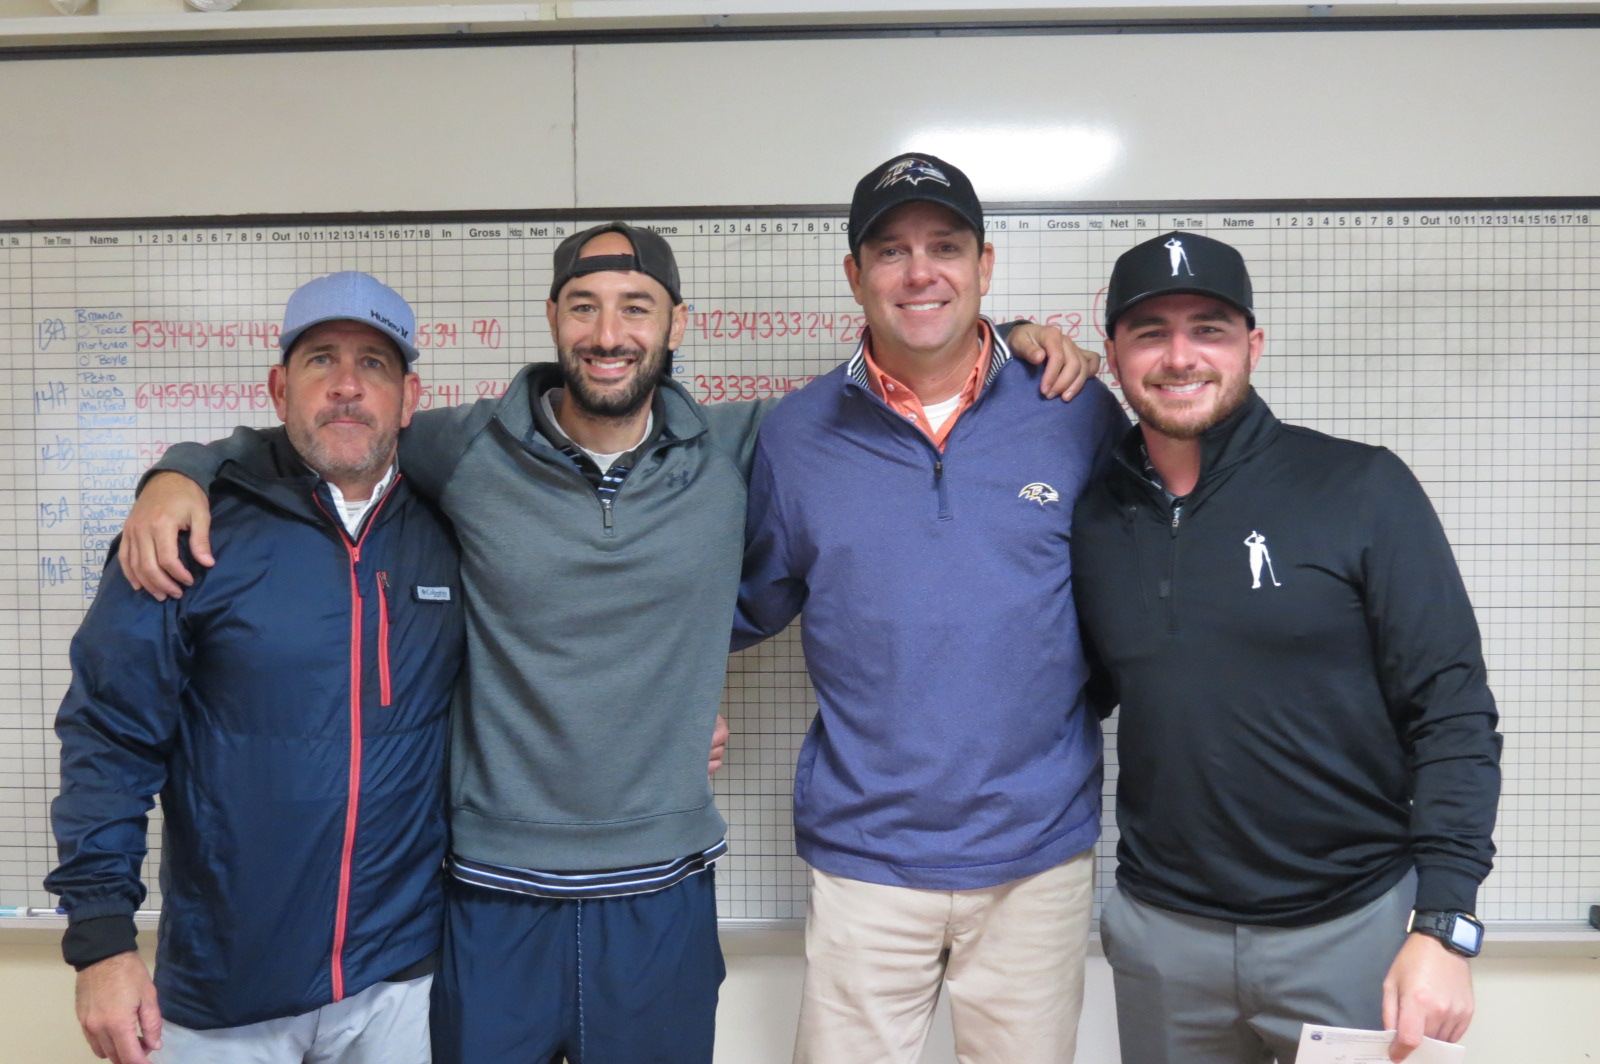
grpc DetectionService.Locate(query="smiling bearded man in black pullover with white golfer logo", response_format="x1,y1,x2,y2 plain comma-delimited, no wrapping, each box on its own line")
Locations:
1072,232,1499,1064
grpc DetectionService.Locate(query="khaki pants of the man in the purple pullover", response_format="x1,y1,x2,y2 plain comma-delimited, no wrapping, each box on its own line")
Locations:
794,851,1094,1064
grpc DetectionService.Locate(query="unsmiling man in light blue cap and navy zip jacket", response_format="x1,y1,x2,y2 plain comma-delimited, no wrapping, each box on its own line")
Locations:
46,272,462,1064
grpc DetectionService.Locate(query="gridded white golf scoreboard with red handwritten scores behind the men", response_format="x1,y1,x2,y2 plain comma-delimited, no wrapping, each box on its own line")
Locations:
0,202,1600,920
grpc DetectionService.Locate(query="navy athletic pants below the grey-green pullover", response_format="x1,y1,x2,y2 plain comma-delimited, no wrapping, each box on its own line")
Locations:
432,869,725,1064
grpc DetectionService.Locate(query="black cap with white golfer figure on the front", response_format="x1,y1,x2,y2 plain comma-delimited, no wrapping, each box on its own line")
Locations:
1106,232,1256,336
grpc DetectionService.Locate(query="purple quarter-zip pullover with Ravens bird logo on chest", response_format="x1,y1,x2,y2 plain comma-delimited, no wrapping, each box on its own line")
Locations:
736,323,1128,890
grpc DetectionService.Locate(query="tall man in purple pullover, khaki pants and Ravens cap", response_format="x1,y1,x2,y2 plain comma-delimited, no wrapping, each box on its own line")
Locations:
736,154,1128,1064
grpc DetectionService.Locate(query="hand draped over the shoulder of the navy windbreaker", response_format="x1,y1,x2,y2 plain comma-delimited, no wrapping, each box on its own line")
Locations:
118,472,216,602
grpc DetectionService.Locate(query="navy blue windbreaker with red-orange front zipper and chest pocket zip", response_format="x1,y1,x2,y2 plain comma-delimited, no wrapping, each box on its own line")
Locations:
45,432,462,1029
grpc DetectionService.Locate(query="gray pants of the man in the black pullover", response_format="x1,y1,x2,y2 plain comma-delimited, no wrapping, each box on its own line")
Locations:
1101,872,1416,1064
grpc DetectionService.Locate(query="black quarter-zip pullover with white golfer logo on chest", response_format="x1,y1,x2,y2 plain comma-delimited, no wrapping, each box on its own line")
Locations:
1072,392,1499,926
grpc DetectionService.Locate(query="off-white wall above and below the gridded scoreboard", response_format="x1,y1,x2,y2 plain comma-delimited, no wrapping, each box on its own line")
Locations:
0,30,1600,1064
